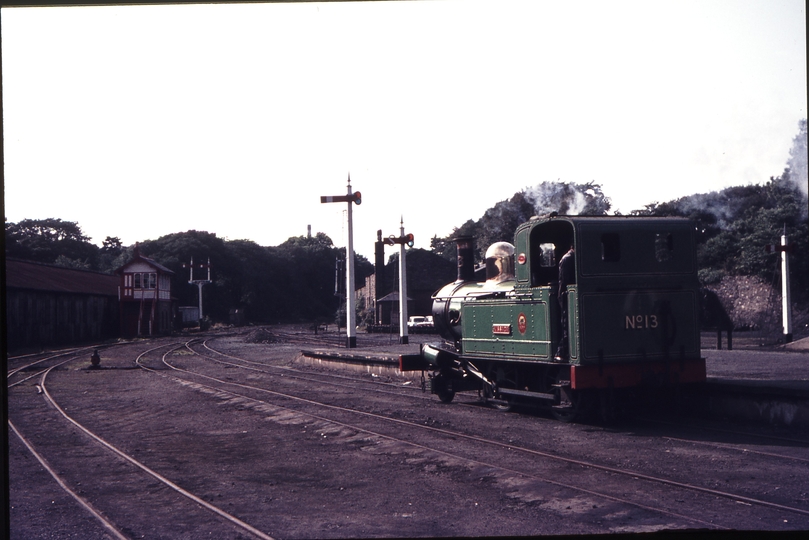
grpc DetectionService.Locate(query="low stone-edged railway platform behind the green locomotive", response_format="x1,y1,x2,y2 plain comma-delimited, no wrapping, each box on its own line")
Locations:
302,334,809,429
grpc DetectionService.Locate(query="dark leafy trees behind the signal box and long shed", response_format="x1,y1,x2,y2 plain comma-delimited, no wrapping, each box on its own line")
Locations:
5,219,373,323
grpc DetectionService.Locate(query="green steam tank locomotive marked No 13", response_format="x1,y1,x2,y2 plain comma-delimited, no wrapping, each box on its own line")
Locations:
400,214,705,421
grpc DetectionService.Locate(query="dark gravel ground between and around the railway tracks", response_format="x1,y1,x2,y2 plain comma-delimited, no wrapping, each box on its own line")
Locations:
9,326,807,540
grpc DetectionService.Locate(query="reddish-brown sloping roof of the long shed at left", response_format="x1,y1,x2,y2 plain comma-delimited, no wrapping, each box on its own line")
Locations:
6,259,119,296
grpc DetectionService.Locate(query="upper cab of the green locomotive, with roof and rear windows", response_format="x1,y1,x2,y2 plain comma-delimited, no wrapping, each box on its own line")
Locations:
514,215,696,287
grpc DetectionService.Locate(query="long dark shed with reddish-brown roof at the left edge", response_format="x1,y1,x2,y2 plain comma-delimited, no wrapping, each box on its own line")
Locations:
5,259,119,351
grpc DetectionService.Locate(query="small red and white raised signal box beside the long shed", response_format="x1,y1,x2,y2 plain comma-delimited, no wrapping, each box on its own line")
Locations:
115,246,174,338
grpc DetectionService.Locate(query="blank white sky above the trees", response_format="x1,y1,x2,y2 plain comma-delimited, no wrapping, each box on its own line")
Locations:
0,0,807,259
